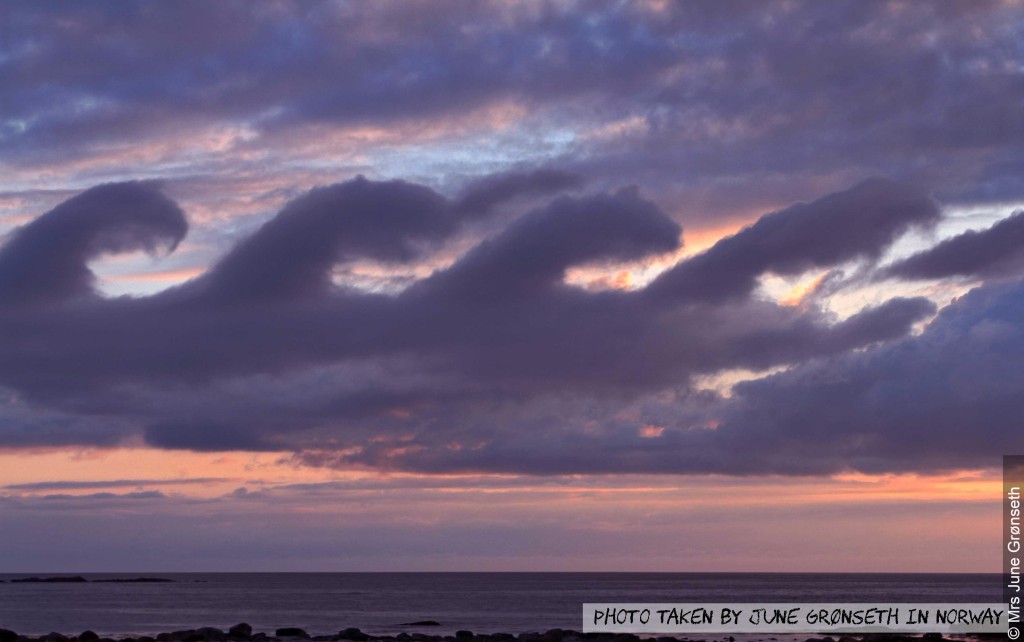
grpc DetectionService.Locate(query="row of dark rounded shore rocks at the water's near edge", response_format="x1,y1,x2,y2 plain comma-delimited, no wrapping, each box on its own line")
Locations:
0,620,1007,642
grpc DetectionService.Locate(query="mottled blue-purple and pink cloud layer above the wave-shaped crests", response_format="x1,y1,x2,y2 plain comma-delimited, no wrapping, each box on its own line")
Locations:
0,1,1024,222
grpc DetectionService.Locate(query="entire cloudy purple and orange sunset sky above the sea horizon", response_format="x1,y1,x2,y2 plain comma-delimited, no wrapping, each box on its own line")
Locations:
0,0,1024,572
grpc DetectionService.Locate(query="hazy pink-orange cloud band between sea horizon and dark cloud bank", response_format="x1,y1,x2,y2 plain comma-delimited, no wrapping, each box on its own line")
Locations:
0,476,996,573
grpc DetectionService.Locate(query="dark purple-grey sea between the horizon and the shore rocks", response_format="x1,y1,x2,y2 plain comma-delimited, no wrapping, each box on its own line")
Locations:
0,573,1002,637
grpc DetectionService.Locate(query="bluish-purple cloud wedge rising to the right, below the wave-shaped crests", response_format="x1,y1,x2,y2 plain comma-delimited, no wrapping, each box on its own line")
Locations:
327,282,1024,475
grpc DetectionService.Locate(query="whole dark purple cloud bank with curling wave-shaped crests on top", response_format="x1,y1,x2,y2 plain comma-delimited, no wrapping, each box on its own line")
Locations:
0,172,1024,475
